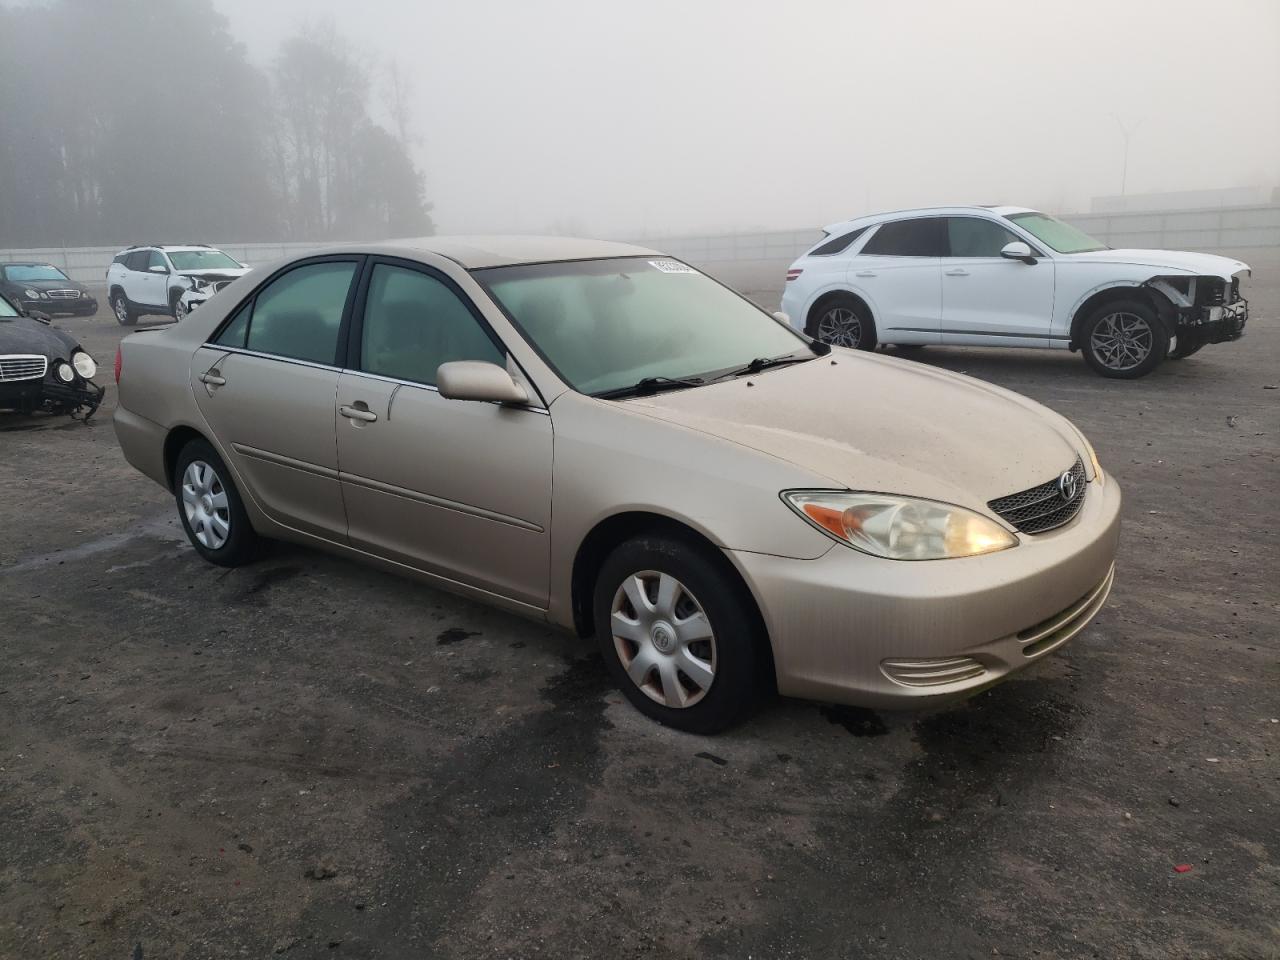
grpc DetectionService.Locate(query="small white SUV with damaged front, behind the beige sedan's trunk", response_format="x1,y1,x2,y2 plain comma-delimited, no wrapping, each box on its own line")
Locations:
106,243,250,326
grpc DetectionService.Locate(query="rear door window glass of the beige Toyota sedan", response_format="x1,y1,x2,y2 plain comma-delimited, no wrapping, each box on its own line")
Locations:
240,261,356,364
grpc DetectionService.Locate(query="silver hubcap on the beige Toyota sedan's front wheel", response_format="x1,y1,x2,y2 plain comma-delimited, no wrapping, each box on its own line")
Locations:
609,570,716,708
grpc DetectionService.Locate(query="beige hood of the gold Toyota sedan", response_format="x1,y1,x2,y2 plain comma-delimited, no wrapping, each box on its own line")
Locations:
614,351,1089,508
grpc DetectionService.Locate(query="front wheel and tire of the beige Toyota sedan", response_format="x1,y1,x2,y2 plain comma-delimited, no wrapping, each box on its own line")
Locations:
591,535,771,733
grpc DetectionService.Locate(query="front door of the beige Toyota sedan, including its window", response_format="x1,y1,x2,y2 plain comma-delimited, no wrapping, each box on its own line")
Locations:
337,260,552,607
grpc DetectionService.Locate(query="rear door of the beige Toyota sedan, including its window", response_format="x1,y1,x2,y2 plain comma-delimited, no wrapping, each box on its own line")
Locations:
191,257,362,541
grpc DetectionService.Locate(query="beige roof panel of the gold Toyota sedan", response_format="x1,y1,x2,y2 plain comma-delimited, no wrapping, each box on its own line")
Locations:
343,236,662,270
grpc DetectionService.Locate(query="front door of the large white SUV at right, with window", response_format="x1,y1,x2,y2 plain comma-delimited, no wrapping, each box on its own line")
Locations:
942,216,1065,347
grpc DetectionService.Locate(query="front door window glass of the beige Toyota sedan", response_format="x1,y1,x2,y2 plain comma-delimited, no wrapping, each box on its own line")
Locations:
360,264,506,385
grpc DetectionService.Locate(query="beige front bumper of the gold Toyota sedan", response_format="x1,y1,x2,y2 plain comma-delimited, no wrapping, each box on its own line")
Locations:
728,476,1120,709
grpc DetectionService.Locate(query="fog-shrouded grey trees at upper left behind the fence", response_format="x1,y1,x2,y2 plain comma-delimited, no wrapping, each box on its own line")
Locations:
0,0,433,247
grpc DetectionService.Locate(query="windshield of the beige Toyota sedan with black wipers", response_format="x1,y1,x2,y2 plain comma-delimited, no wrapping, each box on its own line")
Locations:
474,256,813,394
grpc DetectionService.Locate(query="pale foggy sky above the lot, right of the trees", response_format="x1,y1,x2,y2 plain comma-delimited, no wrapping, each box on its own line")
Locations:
215,0,1280,237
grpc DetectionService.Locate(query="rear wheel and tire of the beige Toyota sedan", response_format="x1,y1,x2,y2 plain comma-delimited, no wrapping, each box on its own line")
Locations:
173,440,259,567
